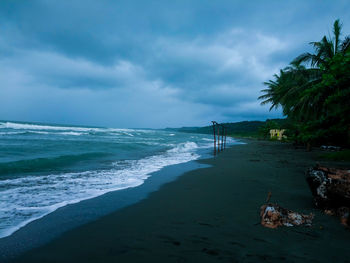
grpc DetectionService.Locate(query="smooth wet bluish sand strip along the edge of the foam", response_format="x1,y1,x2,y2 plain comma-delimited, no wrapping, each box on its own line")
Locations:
0,150,209,261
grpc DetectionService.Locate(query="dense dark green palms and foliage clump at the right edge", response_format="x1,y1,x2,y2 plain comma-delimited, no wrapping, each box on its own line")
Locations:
259,20,350,146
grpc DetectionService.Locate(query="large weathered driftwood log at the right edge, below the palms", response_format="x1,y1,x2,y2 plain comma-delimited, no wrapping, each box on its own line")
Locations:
306,166,350,226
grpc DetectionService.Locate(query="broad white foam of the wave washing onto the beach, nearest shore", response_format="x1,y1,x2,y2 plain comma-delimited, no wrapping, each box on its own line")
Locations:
0,142,199,237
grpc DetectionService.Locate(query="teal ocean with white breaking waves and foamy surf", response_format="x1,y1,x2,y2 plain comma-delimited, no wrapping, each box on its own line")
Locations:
0,121,235,238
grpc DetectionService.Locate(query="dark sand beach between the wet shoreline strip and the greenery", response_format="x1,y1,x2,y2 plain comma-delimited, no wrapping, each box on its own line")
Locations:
10,141,350,262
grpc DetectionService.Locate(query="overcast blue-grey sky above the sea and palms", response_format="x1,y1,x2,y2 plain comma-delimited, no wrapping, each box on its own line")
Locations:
0,0,350,128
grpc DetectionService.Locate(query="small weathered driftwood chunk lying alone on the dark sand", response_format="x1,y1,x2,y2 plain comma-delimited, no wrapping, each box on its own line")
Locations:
260,203,313,228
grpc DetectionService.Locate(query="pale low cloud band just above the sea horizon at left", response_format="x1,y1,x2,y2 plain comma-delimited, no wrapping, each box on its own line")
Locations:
0,48,209,127
